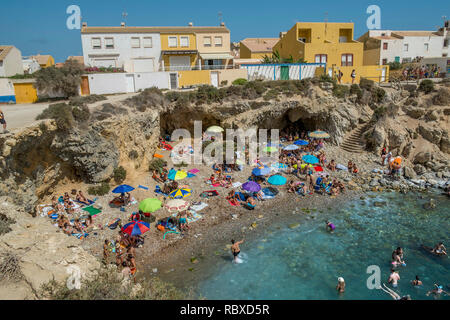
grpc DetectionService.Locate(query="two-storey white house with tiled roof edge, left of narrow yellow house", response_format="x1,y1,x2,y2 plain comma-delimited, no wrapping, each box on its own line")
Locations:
81,23,161,72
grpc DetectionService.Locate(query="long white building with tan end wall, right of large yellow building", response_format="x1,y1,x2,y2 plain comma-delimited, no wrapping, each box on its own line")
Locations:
358,30,448,65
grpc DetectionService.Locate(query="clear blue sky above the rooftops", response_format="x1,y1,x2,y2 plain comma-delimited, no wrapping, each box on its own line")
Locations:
0,0,450,62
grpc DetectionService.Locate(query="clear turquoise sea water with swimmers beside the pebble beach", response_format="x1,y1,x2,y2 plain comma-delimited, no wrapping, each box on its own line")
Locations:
198,193,450,300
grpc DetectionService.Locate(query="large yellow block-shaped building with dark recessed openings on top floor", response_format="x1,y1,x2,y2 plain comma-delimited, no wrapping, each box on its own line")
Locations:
273,22,389,83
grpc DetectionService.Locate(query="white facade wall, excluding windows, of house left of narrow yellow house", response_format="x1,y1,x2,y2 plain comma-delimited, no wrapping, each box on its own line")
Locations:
81,33,161,72
